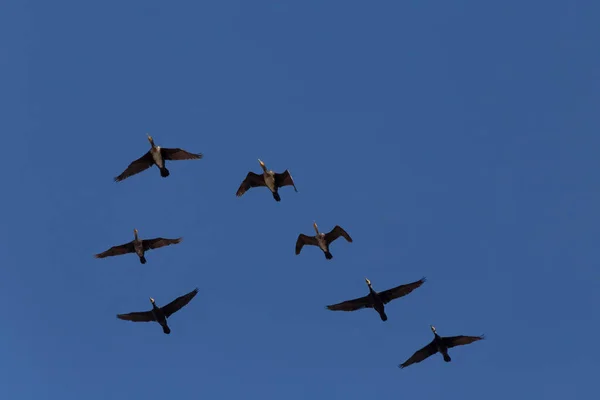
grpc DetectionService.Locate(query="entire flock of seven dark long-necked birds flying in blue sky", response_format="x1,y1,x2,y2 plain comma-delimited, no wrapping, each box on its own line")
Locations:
95,135,484,368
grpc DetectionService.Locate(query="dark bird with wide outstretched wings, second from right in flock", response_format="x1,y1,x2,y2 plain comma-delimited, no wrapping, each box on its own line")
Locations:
326,277,426,321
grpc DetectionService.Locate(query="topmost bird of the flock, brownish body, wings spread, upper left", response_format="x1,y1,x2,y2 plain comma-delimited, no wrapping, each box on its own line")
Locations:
115,134,204,182
